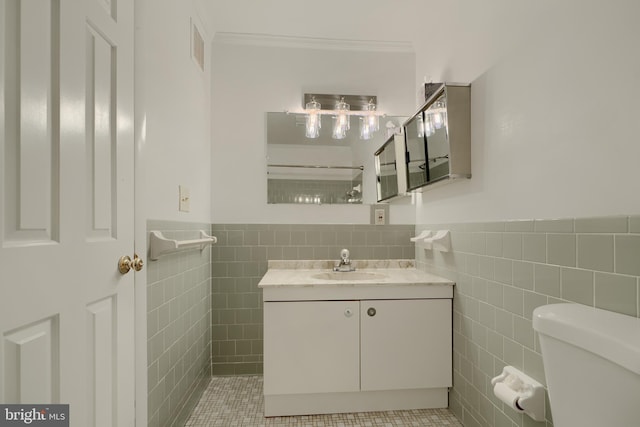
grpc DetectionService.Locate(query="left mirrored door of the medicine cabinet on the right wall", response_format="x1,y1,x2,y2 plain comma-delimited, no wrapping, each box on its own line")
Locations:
404,112,429,190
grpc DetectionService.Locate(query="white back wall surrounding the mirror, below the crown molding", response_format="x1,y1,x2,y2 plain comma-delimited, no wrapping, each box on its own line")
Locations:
211,40,416,224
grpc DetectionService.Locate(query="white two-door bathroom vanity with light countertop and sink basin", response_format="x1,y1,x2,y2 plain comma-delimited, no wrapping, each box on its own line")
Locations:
260,260,453,416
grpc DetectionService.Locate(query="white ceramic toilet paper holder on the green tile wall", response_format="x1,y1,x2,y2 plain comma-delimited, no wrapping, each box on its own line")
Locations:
491,366,544,421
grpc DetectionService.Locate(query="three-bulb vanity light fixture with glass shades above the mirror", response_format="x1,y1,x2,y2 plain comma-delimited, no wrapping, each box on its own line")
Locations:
294,93,385,139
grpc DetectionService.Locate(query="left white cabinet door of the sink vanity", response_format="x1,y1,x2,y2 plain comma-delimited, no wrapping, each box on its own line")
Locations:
264,301,360,395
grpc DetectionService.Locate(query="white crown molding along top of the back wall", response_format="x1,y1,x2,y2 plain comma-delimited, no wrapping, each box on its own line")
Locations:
213,32,415,53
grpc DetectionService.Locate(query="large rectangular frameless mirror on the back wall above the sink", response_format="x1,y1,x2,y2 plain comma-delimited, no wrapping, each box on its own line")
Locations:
266,112,404,204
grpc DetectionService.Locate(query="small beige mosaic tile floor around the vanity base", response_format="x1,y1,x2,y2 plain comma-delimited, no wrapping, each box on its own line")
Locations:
185,376,462,427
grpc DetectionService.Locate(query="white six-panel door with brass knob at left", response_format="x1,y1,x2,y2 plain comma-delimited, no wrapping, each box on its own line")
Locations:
0,0,135,427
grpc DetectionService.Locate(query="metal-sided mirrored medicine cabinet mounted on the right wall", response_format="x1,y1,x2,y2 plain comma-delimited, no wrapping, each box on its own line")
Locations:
403,83,471,191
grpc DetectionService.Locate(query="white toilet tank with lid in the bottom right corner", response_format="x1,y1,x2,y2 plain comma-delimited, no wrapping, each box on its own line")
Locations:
533,304,640,427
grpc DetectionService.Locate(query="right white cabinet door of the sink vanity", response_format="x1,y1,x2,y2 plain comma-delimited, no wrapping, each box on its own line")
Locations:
360,299,452,390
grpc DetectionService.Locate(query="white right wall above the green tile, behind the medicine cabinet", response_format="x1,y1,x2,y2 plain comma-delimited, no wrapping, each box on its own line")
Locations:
417,1,640,223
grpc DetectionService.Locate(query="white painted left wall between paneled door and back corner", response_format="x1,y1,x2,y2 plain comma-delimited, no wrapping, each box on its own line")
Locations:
136,0,212,226
